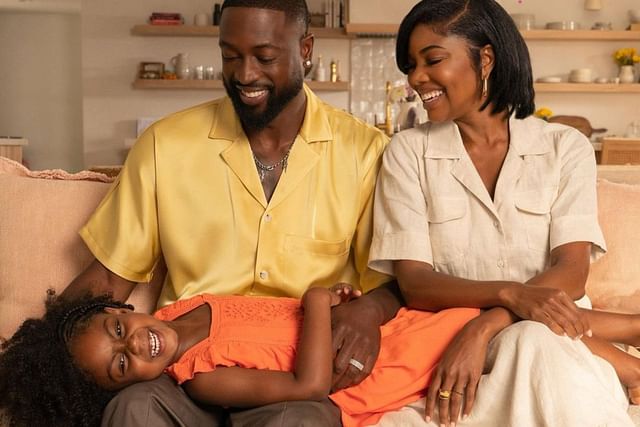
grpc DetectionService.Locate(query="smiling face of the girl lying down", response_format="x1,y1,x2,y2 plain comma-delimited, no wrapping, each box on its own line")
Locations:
69,308,178,390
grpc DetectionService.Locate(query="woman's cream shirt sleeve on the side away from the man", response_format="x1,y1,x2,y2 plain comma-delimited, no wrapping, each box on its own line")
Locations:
550,129,606,262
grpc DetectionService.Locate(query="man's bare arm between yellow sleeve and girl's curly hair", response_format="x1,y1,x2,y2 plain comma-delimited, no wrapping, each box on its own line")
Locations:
61,260,136,301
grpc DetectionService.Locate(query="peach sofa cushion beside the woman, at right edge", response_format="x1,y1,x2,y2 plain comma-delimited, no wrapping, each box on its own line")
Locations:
587,179,640,313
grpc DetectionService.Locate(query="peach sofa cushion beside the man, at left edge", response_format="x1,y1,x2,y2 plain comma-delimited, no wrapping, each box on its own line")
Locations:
0,157,161,344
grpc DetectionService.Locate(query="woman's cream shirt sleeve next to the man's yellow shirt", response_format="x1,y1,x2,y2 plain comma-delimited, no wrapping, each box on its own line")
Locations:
369,130,433,274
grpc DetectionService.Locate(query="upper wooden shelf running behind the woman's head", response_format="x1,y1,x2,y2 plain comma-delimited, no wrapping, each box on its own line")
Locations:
346,24,640,41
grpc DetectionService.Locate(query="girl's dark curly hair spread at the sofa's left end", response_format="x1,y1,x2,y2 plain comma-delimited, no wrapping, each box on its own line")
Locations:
0,295,133,427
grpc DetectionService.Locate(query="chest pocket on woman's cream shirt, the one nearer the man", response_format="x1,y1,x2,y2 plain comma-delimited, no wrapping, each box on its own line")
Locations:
427,197,470,268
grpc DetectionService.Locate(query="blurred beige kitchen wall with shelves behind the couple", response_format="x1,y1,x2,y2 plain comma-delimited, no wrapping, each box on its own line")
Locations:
0,0,640,170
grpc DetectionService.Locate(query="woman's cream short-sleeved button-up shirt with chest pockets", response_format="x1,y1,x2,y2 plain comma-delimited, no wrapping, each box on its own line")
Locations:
369,117,605,282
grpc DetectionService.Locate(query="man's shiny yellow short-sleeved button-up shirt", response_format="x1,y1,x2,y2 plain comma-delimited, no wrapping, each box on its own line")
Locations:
81,86,389,306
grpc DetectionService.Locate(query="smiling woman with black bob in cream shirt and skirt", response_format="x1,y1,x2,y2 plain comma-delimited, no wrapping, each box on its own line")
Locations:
369,0,640,427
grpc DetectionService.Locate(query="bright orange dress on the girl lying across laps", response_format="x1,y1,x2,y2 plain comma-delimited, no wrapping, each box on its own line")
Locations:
155,295,479,427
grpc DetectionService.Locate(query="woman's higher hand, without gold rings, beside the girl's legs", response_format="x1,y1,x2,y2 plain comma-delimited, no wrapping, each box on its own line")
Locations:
505,284,591,339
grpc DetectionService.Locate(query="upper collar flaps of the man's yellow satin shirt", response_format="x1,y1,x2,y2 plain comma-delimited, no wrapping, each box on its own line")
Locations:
209,84,333,143
